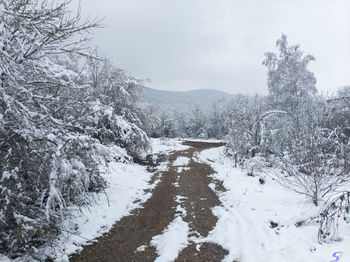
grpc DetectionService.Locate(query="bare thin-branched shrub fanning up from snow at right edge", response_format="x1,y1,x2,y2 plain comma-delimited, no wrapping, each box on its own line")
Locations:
276,130,350,206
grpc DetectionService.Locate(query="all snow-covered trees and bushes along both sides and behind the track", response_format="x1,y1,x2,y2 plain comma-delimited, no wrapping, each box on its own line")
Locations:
0,0,350,258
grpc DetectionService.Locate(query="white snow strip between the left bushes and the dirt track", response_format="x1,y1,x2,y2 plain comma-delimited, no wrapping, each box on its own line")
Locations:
51,162,154,261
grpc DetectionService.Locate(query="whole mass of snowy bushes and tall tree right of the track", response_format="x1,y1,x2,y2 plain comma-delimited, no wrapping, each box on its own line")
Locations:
227,35,350,242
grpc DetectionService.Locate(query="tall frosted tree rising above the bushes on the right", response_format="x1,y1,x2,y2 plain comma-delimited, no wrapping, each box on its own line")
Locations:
263,34,317,138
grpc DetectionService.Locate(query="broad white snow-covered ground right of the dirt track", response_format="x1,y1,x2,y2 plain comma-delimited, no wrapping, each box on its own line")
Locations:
198,147,350,262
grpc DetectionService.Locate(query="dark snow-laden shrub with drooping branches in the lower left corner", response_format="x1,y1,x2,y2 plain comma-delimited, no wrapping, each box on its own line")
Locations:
0,133,105,256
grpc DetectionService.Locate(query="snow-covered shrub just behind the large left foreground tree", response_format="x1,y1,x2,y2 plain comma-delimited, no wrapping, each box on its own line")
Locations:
86,59,153,157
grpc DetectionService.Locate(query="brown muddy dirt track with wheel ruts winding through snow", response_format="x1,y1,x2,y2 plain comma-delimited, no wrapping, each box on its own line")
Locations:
70,142,227,262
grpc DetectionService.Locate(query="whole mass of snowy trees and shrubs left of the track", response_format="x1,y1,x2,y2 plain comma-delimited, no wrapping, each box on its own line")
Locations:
0,0,153,260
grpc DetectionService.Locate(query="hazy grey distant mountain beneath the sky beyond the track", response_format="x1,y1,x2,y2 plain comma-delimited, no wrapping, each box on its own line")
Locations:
140,88,235,108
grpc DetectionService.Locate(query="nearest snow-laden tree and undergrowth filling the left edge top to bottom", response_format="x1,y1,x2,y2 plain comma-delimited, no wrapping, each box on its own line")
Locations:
0,0,104,256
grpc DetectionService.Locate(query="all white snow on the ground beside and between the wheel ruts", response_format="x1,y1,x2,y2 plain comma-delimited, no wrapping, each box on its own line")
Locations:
5,139,350,262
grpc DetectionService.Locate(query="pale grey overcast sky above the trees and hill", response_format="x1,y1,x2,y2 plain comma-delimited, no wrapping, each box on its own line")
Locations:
81,0,350,94
